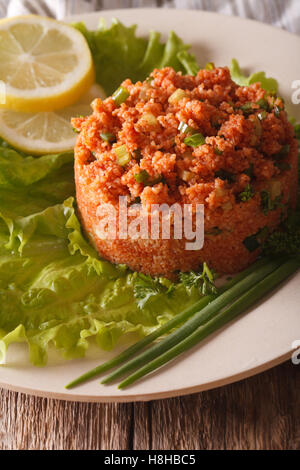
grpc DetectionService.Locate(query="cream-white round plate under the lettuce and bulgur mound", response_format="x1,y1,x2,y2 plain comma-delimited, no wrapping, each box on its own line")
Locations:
0,9,300,402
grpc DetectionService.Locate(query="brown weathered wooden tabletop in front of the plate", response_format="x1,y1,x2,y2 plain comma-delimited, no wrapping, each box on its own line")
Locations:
0,362,300,450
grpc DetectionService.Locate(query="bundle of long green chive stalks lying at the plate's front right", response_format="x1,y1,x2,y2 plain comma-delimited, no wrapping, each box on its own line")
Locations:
67,258,299,389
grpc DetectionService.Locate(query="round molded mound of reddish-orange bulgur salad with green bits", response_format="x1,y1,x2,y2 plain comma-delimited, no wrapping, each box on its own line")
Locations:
73,64,298,277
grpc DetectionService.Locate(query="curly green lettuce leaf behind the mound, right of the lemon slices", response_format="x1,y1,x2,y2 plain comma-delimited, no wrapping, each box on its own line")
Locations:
74,19,199,95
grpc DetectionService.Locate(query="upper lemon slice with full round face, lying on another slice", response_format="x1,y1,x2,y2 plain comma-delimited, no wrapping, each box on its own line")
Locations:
0,15,95,112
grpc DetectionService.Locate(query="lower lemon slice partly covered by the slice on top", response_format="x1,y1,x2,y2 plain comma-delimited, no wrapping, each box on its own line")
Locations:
0,85,105,155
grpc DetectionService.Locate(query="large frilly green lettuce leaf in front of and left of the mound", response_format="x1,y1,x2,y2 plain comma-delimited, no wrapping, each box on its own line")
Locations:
0,146,199,366
